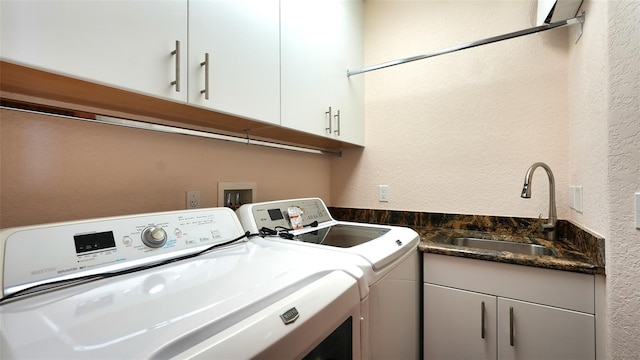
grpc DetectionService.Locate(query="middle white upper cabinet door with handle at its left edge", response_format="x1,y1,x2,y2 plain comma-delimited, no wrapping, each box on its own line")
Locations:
189,0,280,124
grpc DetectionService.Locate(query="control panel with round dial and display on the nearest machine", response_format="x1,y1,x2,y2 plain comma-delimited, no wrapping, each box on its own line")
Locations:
0,208,244,295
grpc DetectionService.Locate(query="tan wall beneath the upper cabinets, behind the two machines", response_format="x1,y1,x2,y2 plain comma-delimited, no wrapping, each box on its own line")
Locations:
0,110,331,228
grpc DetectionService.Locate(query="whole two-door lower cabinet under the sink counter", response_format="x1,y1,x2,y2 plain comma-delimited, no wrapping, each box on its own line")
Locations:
423,254,596,360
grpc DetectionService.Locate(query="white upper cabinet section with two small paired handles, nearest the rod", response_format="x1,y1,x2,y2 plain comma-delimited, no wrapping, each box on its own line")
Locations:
280,0,364,145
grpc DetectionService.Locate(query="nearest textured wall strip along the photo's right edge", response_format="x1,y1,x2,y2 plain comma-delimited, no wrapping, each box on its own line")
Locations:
607,0,640,359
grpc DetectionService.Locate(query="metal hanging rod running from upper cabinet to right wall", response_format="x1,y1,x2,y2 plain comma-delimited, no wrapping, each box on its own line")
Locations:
347,11,585,76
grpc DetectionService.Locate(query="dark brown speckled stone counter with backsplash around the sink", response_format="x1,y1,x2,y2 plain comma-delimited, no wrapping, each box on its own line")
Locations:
329,207,605,275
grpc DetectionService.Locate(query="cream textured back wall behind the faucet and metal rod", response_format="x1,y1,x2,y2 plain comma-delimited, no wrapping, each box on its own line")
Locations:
331,0,572,218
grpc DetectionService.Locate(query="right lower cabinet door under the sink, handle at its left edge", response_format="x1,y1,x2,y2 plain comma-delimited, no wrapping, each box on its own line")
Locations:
498,298,595,360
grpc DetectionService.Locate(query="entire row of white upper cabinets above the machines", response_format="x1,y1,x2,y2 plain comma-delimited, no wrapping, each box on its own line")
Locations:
0,0,364,145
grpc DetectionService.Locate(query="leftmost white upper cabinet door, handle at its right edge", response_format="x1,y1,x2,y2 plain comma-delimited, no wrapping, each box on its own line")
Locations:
0,0,187,101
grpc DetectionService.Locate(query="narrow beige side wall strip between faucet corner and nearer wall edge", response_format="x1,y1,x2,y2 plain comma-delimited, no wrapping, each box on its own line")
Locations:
568,1,609,237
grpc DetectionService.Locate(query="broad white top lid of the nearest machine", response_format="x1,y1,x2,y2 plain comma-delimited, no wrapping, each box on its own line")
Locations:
0,242,350,359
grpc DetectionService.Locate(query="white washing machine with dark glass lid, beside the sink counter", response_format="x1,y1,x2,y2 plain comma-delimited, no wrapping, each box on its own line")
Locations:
236,198,420,359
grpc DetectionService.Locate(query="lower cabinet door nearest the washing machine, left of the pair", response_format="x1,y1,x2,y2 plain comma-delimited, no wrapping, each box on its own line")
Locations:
424,284,496,360
